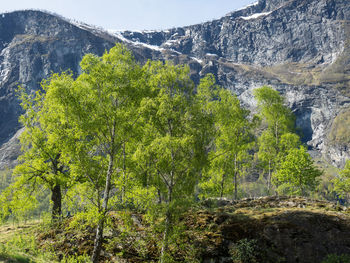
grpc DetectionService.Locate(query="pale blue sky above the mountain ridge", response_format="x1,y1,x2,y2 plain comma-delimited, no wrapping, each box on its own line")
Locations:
0,0,256,30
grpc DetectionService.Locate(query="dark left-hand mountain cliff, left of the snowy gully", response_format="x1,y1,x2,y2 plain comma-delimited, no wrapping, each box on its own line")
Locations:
0,11,113,144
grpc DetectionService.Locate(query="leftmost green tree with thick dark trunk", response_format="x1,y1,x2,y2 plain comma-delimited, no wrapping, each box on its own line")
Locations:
0,84,69,219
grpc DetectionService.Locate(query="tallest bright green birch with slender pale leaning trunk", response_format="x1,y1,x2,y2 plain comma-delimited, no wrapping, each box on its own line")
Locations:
44,44,147,262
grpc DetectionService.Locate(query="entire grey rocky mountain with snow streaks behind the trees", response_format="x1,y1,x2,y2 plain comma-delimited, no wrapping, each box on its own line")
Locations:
0,0,350,168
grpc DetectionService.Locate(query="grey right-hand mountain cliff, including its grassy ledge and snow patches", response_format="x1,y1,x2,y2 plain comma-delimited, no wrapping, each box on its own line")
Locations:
116,0,350,166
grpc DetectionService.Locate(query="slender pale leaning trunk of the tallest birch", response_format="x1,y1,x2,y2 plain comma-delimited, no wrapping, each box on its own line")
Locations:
91,153,114,263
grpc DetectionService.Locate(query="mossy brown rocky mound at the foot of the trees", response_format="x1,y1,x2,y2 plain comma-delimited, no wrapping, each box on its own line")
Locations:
37,197,350,263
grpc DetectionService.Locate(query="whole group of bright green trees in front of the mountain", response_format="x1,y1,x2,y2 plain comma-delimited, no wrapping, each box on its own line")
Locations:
0,44,328,262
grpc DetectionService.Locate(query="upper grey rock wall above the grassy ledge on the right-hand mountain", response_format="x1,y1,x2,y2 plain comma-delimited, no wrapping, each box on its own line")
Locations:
119,0,350,65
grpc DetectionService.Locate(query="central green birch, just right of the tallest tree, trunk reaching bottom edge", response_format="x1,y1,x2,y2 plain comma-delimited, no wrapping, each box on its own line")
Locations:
134,62,210,262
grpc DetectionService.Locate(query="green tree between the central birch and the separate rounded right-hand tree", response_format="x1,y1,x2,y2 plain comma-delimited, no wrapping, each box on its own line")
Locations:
199,82,253,199
